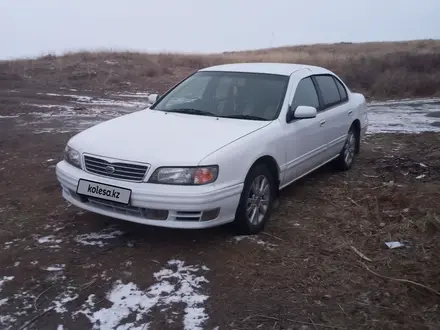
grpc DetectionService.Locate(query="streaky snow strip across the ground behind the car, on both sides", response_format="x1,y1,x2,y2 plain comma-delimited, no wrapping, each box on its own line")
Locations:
14,91,440,135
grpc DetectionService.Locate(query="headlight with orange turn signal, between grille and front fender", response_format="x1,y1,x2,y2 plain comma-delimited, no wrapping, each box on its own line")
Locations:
148,166,218,185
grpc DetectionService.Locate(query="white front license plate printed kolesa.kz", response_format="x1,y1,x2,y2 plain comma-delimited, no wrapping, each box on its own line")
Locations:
76,179,131,204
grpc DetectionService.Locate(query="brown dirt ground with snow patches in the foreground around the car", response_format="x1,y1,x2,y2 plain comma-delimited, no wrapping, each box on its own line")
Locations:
0,93,440,330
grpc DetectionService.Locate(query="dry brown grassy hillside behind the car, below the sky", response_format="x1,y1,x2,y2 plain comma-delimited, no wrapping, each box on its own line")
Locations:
0,40,440,99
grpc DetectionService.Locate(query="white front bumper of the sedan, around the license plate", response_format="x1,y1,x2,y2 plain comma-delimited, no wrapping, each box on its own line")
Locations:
56,160,243,229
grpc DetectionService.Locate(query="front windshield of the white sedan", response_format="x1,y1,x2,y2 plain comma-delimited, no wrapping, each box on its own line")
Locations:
151,71,289,120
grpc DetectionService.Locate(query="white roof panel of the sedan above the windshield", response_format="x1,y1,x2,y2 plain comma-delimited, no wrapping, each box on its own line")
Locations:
199,62,331,76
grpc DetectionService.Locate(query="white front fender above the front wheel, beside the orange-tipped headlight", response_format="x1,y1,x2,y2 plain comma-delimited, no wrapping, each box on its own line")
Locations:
199,120,285,189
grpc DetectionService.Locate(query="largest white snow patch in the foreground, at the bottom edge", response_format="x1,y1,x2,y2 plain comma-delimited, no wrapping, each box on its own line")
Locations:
74,260,208,330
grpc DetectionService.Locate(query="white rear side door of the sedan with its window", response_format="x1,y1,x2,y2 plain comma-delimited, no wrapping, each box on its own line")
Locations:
313,74,351,160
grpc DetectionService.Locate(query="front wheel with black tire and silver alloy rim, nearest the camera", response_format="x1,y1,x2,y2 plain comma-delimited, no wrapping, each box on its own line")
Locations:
234,164,276,235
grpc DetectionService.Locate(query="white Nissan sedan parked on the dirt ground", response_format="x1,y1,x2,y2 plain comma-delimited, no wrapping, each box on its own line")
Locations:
56,63,368,234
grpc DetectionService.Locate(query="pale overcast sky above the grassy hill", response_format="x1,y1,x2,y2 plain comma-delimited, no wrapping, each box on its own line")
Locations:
0,0,440,59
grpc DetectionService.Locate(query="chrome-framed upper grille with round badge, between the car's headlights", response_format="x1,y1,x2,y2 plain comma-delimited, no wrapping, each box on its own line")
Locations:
84,156,148,182
